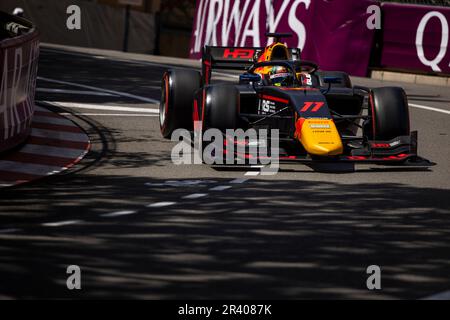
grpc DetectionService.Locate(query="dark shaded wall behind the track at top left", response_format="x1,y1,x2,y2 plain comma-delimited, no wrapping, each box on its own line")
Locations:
0,0,156,53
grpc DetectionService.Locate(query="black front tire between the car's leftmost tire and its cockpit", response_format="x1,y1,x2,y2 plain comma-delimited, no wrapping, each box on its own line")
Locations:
205,85,239,131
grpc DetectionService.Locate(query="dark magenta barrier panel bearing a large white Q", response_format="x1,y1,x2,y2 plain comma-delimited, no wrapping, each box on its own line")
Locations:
381,3,450,74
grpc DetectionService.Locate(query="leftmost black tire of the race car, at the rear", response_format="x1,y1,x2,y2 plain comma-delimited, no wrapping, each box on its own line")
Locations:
159,69,202,138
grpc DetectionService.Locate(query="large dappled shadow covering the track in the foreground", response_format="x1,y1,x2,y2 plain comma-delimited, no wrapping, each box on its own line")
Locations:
0,174,450,299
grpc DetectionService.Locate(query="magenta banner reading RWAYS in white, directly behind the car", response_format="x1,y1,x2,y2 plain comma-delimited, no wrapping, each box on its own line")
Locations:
190,0,376,76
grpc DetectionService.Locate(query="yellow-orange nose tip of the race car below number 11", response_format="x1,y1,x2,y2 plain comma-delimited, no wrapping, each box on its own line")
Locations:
298,119,344,156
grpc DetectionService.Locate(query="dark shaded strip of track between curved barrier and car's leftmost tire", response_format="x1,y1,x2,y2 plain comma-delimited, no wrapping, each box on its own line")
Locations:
36,51,166,105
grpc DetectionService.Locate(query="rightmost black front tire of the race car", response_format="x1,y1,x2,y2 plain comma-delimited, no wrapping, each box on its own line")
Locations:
365,87,410,141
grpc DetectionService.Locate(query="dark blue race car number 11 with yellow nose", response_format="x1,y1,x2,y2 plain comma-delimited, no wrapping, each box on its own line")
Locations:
160,34,432,166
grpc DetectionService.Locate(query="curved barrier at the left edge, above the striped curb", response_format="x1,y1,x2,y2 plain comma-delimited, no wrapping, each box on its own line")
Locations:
0,12,39,152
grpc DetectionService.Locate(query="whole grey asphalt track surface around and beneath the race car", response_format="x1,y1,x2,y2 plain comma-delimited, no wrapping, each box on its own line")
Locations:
0,43,450,299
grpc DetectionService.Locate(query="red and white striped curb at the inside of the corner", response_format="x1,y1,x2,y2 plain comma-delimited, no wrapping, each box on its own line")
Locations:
0,107,91,187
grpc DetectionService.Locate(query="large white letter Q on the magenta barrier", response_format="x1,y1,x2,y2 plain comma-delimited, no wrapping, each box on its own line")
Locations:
416,11,450,72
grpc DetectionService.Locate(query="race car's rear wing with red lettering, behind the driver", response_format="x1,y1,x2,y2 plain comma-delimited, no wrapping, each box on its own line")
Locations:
202,46,300,85
